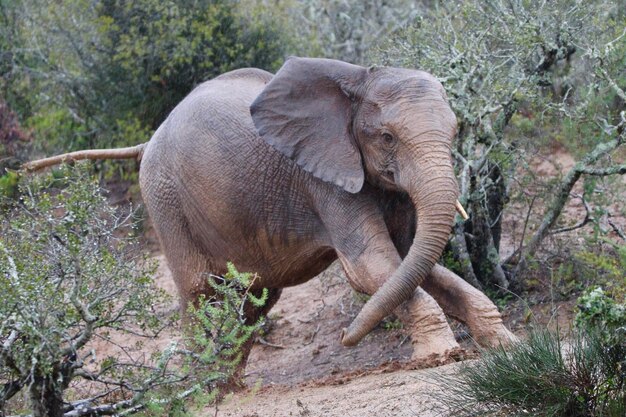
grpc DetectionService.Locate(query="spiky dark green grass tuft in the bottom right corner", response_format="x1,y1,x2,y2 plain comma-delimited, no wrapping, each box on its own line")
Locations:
440,328,626,417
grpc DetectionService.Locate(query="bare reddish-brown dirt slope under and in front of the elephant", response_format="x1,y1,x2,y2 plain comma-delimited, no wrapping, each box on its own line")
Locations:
144,256,475,417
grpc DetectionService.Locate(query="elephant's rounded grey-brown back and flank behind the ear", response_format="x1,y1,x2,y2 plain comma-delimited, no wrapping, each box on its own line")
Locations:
140,69,334,279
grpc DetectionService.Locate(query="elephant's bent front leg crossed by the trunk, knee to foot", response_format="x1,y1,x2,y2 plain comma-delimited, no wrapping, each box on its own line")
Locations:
337,228,458,359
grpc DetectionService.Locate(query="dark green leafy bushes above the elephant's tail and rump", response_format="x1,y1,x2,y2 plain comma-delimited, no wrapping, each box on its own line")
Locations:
0,0,289,158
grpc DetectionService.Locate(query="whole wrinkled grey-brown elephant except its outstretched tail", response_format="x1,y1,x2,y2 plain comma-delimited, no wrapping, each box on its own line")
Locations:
140,58,512,364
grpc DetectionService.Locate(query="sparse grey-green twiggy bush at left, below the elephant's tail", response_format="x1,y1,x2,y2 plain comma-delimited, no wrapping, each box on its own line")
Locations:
0,164,161,414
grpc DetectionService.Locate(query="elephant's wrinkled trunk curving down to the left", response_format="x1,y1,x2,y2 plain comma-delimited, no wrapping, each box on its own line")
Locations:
341,146,458,346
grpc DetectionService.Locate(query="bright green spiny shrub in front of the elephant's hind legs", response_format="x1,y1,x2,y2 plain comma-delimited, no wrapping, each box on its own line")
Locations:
130,263,268,415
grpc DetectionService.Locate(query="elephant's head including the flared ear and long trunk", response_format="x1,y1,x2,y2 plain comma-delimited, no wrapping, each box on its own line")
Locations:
251,58,458,345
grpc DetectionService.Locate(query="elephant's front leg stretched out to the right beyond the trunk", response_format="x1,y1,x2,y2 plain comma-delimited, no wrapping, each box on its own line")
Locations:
422,265,517,346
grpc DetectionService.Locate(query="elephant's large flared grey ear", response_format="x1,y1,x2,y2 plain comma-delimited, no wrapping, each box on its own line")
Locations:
250,58,368,193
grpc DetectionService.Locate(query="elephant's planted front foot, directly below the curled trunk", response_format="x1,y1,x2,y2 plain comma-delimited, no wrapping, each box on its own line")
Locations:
396,288,459,361
